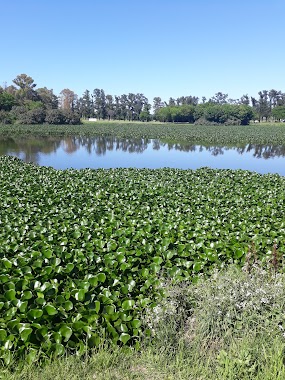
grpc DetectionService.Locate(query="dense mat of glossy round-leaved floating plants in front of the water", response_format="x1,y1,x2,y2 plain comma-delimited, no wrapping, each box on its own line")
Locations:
0,157,285,362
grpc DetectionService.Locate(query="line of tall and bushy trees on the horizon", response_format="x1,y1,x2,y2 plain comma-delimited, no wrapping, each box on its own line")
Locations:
0,74,285,125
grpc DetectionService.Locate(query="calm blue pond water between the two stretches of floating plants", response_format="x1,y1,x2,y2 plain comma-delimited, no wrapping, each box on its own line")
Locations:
0,136,285,175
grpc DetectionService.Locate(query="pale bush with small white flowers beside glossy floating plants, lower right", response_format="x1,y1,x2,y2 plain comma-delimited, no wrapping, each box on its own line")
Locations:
146,266,285,341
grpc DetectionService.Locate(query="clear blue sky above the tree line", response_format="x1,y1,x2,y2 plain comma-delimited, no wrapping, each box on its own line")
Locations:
0,0,285,103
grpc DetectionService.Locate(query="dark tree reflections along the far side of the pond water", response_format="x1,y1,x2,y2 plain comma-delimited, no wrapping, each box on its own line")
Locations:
0,136,285,163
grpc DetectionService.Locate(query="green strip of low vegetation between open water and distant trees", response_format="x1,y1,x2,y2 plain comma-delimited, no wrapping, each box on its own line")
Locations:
0,121,285,145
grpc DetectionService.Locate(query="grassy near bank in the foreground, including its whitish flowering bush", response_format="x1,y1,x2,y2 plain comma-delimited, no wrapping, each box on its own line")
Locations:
0,266,285,380
